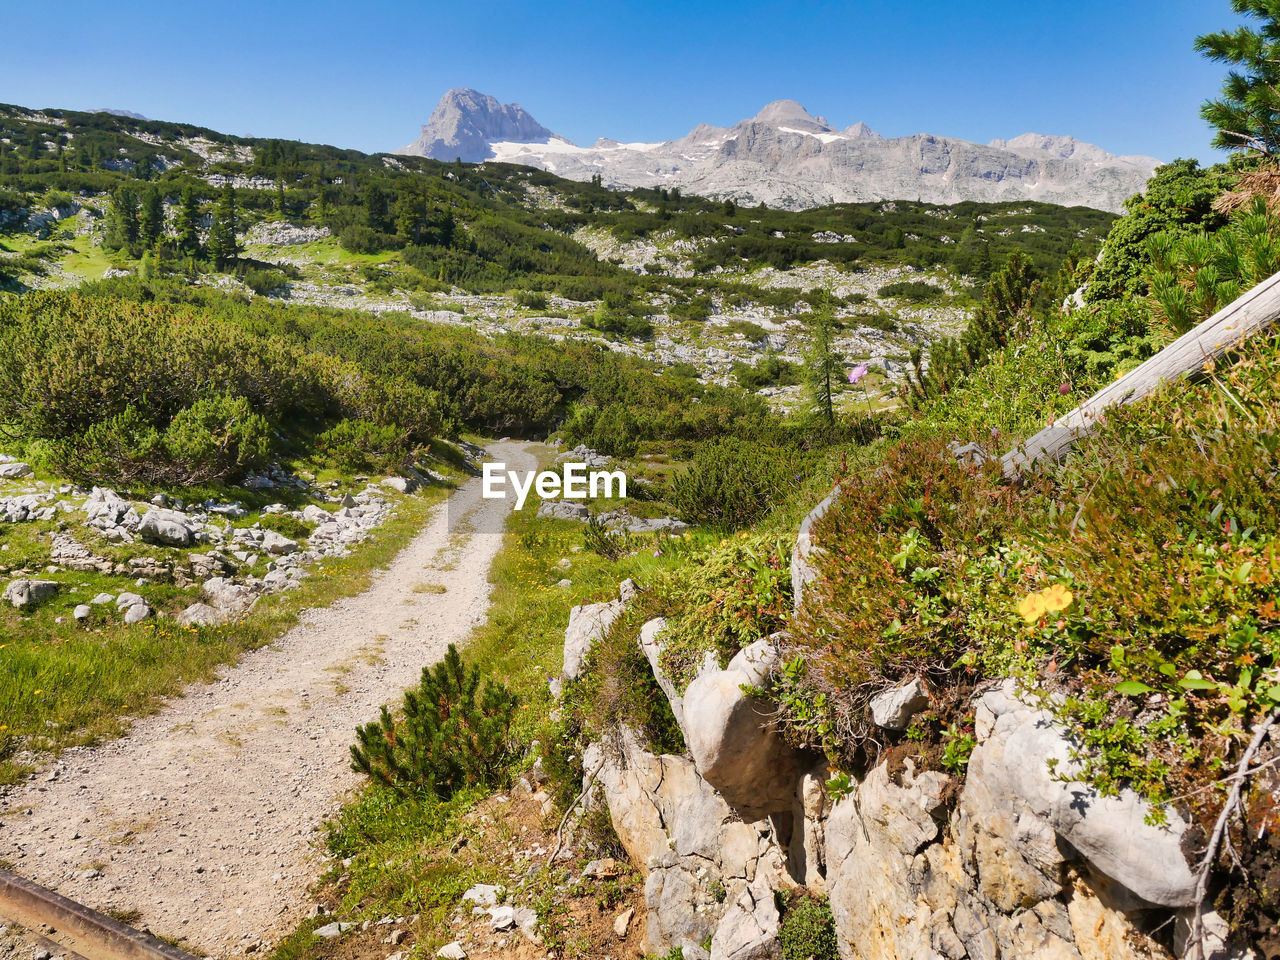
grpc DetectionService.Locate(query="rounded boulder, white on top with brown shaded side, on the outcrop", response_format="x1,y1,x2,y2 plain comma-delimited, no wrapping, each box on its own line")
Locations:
680,640,809,819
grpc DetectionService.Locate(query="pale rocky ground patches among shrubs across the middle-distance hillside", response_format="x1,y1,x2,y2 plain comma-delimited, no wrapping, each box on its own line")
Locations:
7,200,968,408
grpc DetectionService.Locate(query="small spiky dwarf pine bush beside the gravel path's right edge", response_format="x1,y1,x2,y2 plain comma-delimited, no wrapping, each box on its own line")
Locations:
351,644,517,800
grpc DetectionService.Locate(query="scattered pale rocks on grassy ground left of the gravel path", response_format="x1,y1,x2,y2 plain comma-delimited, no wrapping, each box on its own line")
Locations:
0,454,450,625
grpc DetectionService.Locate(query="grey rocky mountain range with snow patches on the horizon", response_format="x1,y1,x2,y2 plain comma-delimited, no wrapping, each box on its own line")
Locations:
396,90,1160,211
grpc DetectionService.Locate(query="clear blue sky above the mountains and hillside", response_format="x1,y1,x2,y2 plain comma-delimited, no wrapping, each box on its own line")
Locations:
0,0,1235,160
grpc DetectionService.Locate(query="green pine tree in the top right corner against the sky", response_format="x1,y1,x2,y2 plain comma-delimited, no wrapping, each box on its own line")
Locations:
1196,0,1280,156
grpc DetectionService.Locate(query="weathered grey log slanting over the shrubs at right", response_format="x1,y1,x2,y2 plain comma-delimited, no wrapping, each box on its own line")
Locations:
1000,273,1280,479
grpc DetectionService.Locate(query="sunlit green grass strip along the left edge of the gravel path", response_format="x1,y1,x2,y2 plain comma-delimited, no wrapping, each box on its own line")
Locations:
0,486,458,783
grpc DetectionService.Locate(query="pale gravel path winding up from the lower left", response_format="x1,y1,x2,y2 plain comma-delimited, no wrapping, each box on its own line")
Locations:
0,443,536,957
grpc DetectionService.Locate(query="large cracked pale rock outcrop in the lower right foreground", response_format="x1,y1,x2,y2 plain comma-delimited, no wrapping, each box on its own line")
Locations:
566,497,1216,960
